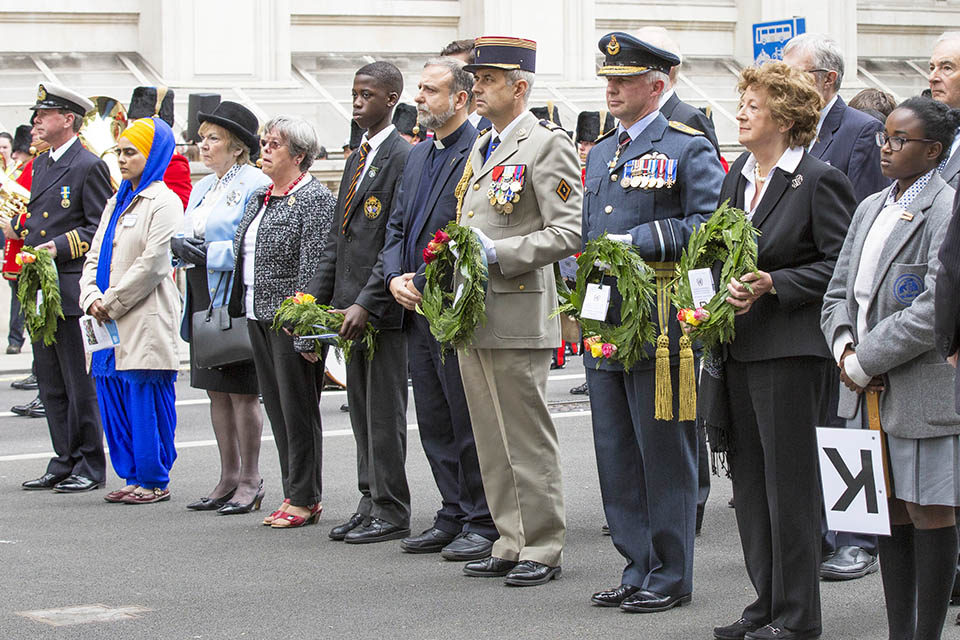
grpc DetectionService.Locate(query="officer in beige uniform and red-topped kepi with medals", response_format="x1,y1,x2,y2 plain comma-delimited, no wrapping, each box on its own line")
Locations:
460,37,583,586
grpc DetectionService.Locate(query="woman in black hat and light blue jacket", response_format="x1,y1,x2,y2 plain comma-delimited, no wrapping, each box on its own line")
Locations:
171,102,270,515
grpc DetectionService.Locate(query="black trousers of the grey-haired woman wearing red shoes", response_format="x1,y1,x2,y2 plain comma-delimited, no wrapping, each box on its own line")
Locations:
247,320,323,507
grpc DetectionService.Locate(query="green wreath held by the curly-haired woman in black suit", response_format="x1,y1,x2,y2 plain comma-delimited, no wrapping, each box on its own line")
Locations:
670,200,760,349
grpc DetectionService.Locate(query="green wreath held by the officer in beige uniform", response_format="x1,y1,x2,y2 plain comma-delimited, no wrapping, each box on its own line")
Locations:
417,221,488,355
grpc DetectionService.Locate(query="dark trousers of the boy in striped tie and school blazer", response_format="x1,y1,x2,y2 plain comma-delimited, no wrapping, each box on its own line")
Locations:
347,329,410,527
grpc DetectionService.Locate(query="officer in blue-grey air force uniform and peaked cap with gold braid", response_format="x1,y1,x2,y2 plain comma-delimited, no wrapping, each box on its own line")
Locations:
583,32,724,613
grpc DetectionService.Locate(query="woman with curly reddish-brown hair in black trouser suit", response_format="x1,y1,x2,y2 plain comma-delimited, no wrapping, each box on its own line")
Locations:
703,62,856,640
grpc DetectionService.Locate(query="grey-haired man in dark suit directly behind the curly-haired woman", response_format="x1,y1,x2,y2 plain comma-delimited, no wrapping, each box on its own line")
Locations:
783,33,890,580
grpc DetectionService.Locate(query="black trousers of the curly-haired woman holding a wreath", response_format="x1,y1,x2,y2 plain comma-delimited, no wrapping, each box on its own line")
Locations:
725,357,831,631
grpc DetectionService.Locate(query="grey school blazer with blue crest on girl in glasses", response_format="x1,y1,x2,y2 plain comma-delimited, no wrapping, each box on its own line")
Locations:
820,174,960,438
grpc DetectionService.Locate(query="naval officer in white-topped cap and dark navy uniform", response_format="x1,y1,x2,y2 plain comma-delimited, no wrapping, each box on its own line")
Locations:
4,83,113,493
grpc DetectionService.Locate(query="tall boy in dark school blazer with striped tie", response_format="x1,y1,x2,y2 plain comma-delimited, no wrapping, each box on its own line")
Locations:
306,62,411,544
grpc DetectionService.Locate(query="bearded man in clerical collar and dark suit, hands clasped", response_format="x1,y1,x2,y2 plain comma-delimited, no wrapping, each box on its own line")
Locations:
377,57,499,561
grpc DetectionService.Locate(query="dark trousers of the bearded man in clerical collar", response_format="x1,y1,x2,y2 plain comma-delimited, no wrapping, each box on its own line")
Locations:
404,313,500,540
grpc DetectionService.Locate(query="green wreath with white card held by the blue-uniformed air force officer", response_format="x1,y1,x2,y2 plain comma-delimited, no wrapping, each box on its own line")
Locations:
551,234,657,371
